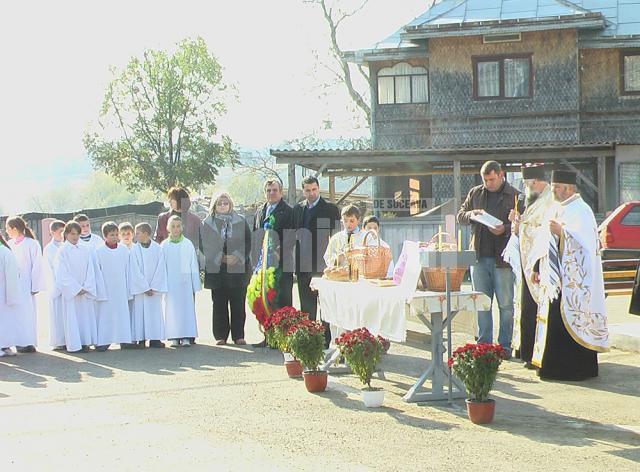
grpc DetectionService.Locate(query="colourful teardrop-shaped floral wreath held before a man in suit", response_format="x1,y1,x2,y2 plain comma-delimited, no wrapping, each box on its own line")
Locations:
247,215,282,330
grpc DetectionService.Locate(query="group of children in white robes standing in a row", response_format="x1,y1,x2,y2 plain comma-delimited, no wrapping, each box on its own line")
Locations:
0,215,201,357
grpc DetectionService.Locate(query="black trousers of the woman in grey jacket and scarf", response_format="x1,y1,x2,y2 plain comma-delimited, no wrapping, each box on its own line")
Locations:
211,286,247,341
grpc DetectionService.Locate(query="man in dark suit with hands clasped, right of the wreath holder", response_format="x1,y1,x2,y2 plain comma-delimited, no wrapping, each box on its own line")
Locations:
293,176,340,347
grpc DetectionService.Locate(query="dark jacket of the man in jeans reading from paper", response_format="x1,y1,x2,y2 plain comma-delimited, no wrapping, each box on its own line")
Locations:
458,181,524,267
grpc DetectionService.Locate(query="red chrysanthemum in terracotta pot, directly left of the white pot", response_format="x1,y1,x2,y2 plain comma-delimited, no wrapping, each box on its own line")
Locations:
287,320,327,392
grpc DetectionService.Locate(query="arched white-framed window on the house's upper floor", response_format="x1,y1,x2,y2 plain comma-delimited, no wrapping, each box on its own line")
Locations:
378,62,429,105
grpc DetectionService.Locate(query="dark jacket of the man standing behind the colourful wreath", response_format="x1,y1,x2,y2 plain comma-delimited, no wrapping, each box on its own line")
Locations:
252,199,295,273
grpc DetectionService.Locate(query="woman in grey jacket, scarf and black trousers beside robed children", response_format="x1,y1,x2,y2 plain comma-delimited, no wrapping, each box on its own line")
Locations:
200,193,251,346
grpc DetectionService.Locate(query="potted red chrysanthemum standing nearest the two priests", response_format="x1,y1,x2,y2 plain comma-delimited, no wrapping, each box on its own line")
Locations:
448,343,506,424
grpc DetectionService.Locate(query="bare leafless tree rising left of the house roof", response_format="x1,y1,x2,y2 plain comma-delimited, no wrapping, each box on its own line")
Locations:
304,0,371,125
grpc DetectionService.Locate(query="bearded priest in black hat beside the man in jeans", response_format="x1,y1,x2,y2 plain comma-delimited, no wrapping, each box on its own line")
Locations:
509,164,555,369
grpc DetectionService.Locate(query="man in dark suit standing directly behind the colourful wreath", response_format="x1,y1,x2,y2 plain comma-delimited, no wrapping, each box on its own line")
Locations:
252,179,295,347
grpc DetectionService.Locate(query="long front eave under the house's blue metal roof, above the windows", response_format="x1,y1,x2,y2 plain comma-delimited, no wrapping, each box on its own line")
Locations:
401,13,606,40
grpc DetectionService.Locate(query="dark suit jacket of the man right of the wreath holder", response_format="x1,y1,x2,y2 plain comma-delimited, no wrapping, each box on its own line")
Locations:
293,197,340,274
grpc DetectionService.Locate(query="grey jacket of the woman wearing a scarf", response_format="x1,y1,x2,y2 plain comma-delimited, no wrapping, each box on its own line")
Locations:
200,212,251,289
